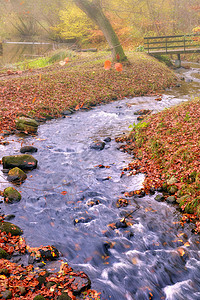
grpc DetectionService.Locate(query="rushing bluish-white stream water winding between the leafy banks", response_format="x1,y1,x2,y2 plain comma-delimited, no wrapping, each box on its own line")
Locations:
0,66,200,300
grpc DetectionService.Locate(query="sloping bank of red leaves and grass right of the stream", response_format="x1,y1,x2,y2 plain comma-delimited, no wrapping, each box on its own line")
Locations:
119,98,200,232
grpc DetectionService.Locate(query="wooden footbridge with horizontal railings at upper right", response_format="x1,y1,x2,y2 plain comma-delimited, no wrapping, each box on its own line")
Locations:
144,34,200,66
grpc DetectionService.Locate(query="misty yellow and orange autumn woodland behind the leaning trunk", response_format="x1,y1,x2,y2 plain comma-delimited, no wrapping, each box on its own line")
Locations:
0,0,200,49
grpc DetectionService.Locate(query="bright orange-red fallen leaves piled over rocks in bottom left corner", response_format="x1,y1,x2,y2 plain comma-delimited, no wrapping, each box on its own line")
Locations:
0,217,99,300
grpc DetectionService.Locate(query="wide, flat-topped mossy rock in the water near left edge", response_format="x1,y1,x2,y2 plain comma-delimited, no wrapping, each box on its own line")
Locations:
2,154,37,170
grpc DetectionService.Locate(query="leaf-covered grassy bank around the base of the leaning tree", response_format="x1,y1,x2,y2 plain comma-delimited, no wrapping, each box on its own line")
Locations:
0,52,175,133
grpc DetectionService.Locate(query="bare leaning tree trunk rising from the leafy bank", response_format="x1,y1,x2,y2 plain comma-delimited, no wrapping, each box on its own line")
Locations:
74,0,127,61
